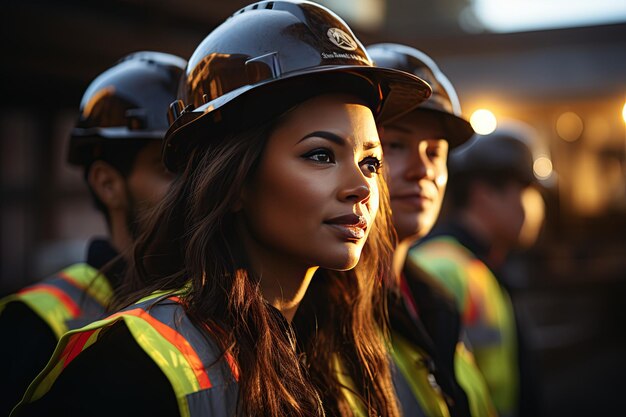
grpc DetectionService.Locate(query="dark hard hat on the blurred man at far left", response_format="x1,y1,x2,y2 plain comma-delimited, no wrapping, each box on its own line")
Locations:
68,51,186,166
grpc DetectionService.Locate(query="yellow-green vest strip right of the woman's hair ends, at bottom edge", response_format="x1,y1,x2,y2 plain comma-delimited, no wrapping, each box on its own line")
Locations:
390,332,450,417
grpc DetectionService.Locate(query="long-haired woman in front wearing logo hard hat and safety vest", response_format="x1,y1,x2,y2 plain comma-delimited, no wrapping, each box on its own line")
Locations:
15,1,430,416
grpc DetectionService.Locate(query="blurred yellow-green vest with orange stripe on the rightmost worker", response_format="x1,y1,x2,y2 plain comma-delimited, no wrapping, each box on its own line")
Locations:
409,236,519,417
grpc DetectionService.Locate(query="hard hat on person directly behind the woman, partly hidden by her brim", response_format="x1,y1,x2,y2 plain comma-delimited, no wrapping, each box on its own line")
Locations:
367,43,474,148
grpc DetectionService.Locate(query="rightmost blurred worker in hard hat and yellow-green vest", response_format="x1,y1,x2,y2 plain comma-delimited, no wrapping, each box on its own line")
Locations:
409,125,536,417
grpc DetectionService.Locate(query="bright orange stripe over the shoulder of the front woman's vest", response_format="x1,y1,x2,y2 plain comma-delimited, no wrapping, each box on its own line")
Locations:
116,308,212,389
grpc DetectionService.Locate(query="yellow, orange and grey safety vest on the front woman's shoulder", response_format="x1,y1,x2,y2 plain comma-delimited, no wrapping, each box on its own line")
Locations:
18,293,239,417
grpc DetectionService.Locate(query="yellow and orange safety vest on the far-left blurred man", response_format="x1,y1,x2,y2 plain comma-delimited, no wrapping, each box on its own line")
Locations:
0,263,113,339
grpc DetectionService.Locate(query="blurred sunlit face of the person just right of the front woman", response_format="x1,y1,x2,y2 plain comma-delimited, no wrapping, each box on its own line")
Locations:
380,111,448,240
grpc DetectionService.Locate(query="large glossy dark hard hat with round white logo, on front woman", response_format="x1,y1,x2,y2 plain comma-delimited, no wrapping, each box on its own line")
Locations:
163,0,431,171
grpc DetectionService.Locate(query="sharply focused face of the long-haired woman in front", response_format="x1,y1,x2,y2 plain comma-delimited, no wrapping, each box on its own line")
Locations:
242,95,382,270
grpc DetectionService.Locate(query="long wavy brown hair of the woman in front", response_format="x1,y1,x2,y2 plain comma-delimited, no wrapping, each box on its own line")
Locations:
120,108,398,416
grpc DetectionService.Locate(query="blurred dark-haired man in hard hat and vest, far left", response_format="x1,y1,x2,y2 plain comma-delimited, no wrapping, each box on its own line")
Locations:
0,52,185,415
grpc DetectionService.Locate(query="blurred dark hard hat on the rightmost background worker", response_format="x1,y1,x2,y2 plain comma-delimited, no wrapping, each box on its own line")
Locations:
448,124,535,184
